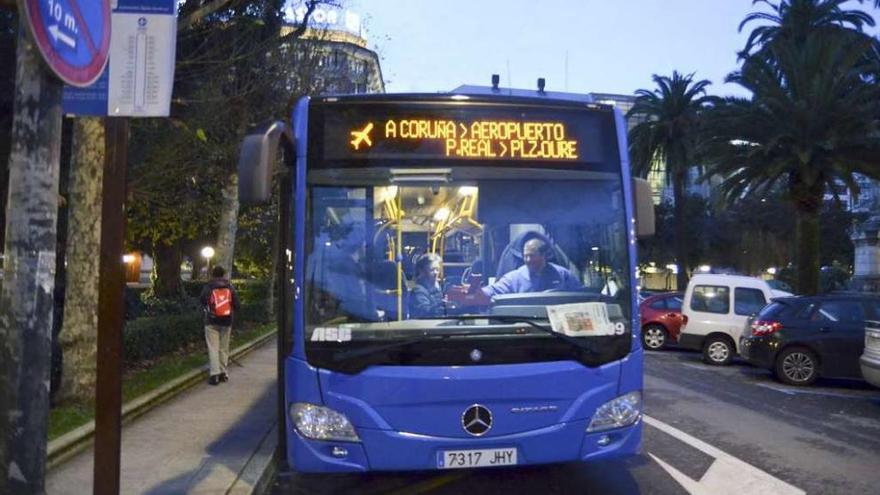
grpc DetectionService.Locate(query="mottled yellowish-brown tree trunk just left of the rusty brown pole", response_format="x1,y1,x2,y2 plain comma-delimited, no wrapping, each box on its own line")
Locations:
60,117,104,401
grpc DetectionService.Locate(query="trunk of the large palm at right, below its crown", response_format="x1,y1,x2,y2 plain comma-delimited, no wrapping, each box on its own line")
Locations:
789,177,823,295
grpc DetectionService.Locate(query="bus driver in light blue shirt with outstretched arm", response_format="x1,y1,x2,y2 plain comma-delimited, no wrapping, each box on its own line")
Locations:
481,238,583,297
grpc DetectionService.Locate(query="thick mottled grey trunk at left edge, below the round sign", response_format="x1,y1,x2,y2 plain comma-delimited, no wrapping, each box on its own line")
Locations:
0,21,62,493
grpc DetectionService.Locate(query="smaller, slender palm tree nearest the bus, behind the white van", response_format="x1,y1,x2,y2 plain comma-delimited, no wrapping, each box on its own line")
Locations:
627,71,711,290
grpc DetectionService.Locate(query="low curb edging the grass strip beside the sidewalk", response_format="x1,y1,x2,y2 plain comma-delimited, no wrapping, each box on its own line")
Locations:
46,331,277,471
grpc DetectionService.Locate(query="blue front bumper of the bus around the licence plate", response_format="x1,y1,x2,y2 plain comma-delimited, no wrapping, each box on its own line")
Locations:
287,419,642,473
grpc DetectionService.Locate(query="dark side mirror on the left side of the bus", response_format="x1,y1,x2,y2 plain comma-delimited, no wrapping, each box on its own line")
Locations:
238,122,294,203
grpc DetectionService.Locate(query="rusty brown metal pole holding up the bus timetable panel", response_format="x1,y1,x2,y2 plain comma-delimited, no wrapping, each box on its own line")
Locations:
93,117,128,495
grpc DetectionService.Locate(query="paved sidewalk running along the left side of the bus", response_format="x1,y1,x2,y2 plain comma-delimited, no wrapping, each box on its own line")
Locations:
46,339,277,494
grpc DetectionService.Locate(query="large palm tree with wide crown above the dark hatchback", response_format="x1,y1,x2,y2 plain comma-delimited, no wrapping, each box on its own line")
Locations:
705,32,880,294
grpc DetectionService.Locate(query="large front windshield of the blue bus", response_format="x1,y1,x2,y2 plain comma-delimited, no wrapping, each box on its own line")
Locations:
305,166,632,368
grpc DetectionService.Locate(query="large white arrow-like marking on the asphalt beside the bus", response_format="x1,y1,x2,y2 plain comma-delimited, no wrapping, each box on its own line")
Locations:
644,416,806,495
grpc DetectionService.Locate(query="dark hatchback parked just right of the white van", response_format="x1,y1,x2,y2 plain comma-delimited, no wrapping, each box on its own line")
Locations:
740,294,880,385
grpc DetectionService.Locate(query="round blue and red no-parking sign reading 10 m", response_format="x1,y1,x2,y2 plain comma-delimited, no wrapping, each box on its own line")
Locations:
19,0,110,86
